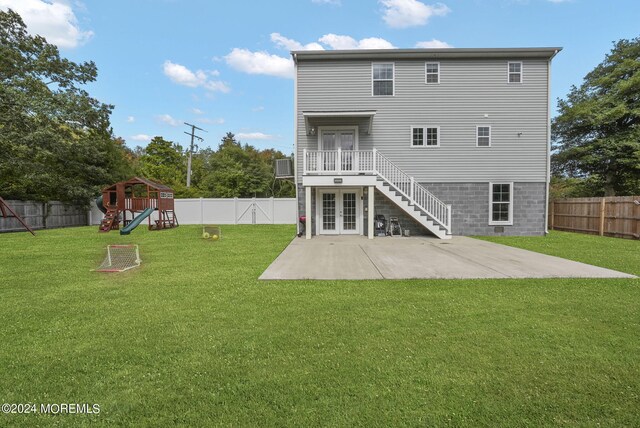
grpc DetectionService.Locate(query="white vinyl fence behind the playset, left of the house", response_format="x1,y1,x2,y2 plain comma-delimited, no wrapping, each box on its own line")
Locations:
90,198,297,225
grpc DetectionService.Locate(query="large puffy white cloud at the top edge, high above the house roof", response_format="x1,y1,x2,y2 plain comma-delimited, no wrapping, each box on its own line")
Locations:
378,0,451,28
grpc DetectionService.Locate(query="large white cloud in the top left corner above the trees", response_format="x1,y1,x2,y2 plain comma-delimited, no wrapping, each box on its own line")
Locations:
0,0,93,48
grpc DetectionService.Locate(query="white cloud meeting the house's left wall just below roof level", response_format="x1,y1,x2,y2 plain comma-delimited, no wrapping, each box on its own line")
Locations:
224,48,293,79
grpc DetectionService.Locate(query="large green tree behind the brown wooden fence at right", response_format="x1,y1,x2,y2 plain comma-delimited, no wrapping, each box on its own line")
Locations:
552,38,640,196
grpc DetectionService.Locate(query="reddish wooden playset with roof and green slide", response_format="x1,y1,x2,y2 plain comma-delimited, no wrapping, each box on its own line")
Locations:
96,177,178,235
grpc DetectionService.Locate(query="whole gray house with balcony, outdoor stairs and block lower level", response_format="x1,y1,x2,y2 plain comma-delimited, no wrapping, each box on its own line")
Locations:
292,48,560,239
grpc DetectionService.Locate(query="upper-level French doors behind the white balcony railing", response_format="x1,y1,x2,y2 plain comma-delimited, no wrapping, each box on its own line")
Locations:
319,126,358,171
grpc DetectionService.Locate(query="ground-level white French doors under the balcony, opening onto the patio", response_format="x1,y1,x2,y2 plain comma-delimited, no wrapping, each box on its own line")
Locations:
316,189,362,235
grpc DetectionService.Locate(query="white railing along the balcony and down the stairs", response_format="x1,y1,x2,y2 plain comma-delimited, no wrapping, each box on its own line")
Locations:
303,149,451,232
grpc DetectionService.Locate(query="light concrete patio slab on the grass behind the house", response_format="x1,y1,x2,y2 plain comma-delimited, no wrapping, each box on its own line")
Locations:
260,236,634,280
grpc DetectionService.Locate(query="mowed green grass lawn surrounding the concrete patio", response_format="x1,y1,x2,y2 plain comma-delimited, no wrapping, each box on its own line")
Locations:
0,226,640,427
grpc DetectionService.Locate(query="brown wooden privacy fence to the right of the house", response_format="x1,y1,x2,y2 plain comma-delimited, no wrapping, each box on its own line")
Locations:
549,196,640,239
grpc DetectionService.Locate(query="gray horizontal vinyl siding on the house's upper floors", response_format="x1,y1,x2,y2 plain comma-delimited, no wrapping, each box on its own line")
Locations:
297,58,548,183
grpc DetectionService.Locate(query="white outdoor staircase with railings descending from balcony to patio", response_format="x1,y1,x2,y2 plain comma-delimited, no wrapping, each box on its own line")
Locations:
373,149,451,239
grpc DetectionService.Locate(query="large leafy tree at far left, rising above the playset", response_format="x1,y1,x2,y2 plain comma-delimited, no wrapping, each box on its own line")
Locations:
0,10,131,201
